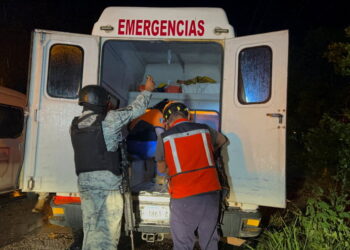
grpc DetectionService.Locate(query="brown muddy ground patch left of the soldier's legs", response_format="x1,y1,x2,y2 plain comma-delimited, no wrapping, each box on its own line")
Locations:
0,191,73,250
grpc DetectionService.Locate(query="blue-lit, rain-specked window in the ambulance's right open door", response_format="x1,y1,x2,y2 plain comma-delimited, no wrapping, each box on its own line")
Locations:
238,46,272,104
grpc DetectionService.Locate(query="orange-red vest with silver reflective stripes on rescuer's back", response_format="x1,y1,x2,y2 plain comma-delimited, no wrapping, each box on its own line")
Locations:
162,119,221,198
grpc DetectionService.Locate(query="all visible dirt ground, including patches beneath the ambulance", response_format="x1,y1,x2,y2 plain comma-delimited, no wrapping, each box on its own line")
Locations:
0,194,241,250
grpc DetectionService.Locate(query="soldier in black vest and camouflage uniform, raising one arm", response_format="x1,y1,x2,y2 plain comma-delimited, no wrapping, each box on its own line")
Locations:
70,77,154,250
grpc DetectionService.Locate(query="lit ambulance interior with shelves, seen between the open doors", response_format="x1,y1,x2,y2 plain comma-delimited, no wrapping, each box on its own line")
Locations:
100,40,223,192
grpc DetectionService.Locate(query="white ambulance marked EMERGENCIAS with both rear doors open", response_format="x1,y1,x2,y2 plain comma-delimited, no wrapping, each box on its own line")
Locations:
15,7,288,241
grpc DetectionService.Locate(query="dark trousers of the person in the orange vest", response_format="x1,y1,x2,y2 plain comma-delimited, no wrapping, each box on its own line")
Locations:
170,192,220,250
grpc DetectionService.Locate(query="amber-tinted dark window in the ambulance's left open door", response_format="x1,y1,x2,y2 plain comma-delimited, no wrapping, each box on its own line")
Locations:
47,44,84,99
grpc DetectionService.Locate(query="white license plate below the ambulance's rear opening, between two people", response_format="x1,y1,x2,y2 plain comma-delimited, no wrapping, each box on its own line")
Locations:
140,205,170,223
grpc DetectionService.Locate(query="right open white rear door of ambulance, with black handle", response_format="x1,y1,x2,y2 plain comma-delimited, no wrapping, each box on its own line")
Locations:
222,31,288,207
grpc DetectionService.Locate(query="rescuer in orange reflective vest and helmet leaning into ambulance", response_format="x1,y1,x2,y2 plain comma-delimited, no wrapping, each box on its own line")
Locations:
156,101,226,250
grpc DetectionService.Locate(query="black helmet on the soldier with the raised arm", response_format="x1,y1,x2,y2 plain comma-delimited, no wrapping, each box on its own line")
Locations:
79,85,109,107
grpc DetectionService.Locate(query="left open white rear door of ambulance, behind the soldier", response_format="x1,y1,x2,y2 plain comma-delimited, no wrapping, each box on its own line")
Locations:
22,30,100,192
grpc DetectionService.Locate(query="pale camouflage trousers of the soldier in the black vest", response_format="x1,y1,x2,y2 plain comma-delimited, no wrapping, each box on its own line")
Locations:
78,171,124,250
